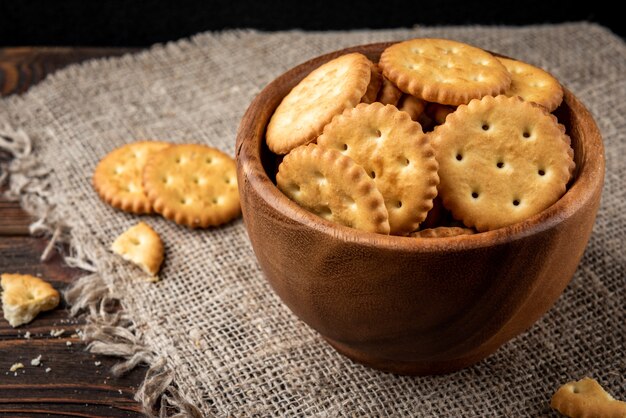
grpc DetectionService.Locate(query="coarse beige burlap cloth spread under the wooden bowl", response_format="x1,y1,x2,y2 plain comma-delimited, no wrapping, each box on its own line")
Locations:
0,22,626,417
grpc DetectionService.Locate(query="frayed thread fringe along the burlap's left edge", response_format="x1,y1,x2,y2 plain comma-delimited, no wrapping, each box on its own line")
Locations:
0,123,202,418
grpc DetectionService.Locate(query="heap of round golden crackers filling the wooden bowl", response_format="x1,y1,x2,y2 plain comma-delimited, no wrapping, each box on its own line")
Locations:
266,38,574,237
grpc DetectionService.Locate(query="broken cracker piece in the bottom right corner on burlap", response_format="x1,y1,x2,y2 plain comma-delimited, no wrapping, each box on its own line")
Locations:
550,377,626,418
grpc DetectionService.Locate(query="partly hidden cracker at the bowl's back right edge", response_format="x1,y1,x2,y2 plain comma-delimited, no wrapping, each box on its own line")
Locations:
497,57,563,112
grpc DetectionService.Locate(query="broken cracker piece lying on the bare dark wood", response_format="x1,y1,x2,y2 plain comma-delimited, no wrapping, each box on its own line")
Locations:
0,274,61,328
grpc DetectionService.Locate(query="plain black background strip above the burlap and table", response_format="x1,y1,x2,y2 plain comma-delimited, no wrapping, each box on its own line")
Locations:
0,0,626,47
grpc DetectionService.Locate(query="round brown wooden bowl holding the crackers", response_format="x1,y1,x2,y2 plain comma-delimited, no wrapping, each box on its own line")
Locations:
236,43,604,374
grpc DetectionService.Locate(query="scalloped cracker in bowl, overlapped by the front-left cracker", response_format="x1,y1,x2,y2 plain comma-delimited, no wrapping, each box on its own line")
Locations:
317,103,439,235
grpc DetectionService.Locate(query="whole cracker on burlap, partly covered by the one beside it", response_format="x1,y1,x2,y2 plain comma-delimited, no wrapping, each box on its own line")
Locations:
92,141,170,214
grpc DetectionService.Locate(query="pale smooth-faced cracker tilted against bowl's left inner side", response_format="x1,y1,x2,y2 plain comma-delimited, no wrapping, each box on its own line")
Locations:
266,52,372,154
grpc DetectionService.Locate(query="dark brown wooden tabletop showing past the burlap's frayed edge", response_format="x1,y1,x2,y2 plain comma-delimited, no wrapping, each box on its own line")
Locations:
0,48,146,417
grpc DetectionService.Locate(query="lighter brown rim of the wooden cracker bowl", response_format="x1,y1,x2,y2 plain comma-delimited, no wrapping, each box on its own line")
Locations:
236,41,605,253
